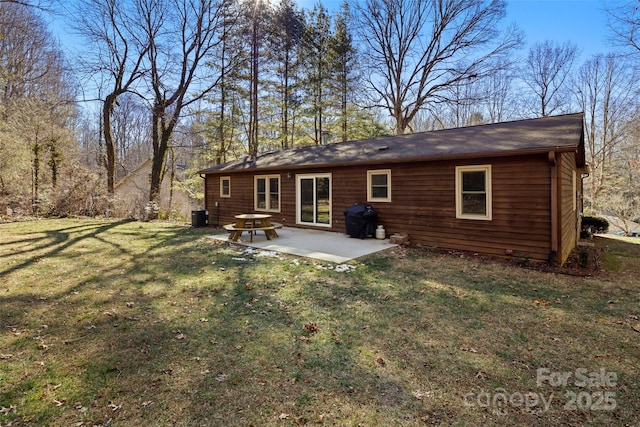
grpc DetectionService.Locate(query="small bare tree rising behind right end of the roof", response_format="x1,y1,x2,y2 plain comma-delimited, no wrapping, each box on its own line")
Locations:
522,40,578,117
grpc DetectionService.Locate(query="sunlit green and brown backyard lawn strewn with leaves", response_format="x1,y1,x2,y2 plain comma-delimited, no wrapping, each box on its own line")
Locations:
0,220,640,427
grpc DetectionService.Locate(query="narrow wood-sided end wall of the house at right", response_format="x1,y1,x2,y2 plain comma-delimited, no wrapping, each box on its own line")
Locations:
557,153,580,265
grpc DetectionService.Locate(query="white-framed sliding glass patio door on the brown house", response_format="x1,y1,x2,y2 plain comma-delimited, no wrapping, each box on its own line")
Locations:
296,174,331,227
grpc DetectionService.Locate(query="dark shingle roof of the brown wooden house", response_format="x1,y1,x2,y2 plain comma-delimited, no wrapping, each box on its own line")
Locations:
200,113,584,174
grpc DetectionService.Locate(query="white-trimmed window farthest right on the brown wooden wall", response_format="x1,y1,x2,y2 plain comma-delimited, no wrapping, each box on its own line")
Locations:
456,165,491,220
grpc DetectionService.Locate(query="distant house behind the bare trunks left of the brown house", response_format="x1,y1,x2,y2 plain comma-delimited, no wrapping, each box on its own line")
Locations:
114,159,196,220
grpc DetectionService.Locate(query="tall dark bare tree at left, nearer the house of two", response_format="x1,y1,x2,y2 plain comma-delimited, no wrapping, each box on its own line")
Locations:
135,0,223,214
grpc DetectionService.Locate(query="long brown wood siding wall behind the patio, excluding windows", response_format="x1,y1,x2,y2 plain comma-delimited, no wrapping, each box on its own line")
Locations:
206,155,551,260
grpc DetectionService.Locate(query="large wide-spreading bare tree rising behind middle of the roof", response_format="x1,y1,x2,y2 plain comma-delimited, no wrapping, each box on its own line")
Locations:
357,0,522,134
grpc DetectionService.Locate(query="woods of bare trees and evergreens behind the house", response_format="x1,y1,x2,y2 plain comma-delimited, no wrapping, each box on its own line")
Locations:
0,0,640,226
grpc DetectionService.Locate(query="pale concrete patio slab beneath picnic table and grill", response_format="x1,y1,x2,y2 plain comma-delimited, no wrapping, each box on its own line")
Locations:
211,227,396,263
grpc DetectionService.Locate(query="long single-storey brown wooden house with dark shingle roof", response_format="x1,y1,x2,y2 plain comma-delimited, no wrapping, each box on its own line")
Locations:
201,113,586,265
